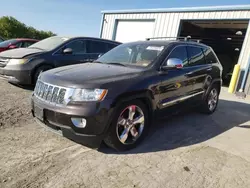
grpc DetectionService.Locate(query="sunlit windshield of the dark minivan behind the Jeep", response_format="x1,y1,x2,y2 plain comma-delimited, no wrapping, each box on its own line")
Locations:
28,36,69,51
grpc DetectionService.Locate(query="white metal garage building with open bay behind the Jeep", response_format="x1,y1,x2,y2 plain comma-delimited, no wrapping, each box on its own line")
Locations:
100,5,250,94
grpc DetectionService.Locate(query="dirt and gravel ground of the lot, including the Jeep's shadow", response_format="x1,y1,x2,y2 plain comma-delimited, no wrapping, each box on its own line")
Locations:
0,80,250,188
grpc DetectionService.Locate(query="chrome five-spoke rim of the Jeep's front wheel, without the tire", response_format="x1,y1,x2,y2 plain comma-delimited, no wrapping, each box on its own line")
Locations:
116,105,145,144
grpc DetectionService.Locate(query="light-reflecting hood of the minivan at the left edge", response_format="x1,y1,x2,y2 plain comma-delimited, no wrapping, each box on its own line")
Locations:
0,48,44,59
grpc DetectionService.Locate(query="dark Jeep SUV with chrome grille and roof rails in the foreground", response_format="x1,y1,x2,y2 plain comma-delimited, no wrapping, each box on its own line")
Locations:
32,41,222,150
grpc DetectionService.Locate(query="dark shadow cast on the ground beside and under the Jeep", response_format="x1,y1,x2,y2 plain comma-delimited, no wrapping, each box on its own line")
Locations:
99,100,250,154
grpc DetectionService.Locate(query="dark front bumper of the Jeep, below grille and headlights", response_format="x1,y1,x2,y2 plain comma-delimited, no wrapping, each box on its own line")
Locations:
31,96,113,148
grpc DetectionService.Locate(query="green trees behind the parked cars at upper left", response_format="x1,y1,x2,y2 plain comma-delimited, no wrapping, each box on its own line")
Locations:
0,16,56,40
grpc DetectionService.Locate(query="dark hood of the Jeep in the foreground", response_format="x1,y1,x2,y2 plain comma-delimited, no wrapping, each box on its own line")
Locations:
41,63,143,88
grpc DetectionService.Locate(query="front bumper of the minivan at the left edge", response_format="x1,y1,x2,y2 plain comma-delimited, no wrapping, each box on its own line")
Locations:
0,65,32,85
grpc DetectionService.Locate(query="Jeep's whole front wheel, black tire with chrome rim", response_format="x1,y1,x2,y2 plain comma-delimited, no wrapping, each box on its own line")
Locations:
104,100,150,151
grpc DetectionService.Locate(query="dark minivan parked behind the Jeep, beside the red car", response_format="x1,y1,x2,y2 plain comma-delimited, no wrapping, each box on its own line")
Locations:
0,36,120,85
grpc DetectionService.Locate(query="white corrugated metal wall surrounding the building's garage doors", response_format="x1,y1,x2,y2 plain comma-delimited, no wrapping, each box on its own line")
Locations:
101,11,250,69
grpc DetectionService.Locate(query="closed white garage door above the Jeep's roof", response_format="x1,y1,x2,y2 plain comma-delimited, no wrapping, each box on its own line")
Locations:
115,20,154,42
